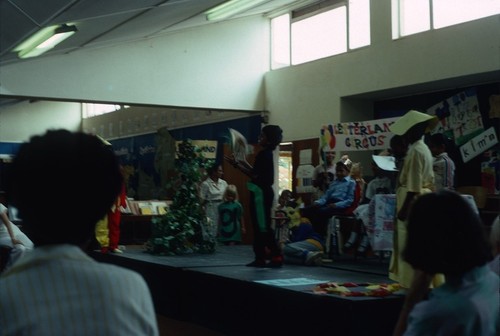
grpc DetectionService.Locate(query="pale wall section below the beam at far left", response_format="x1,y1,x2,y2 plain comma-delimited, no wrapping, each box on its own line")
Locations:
0,101,82,142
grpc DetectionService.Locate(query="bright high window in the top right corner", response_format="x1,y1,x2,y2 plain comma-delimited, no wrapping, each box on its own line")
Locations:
392,0,500,39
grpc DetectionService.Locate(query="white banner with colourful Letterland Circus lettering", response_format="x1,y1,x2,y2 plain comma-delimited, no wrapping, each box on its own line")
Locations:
320,117,399,151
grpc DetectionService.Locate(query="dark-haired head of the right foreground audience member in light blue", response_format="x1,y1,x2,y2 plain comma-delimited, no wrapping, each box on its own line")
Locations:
403,190,493,275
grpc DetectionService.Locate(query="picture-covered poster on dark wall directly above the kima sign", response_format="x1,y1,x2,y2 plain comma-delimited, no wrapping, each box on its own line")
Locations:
427,88,484,146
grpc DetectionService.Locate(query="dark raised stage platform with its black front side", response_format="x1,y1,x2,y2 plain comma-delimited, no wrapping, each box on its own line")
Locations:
92,246,403,336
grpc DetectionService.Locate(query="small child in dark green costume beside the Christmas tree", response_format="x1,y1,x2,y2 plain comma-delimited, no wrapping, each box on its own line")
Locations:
218,184,246,245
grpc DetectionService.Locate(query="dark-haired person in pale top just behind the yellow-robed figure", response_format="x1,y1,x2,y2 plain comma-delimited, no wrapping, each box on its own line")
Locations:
427,133,455,190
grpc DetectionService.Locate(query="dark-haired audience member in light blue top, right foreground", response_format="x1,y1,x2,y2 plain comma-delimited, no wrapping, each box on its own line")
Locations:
394,189,500,336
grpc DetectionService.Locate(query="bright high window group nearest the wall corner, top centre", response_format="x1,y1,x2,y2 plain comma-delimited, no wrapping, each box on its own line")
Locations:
271,0,370,69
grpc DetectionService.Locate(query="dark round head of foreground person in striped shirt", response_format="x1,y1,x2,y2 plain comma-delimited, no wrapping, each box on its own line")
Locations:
9,130,122,246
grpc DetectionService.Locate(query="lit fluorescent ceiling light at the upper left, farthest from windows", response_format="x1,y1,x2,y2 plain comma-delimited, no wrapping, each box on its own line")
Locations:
14,24,77,58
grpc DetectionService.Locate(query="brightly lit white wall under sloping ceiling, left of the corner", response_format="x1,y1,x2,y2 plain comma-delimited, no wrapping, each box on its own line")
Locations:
0,16,269,110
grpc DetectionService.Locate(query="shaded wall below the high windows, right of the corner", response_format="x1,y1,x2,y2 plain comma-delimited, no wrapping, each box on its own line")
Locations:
265,1,500,140
